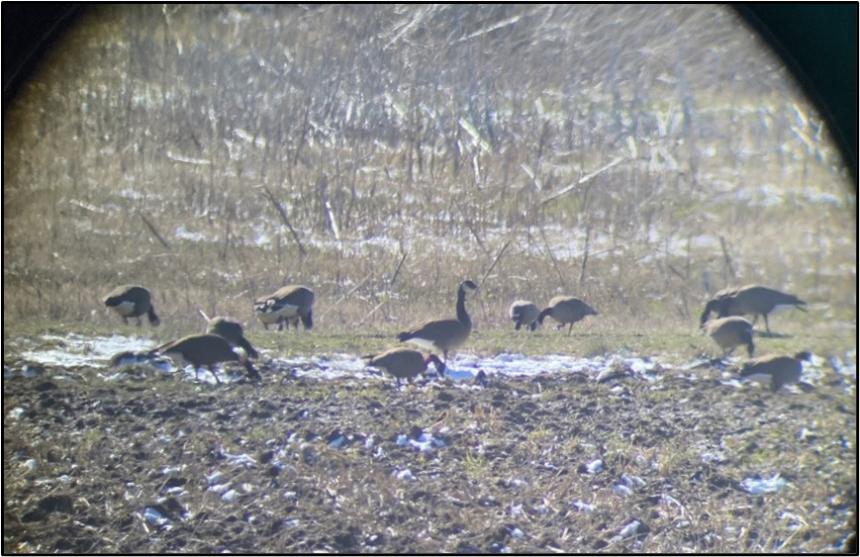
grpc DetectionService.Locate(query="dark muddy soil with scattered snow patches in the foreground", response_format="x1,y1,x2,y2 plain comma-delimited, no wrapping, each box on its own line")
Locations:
3,361,857,553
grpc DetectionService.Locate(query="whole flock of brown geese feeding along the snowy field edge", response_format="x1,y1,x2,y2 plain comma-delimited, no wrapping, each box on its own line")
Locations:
104,280,810,391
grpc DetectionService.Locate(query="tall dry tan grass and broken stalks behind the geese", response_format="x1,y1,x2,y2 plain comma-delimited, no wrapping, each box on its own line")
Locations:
3,5,857,335
